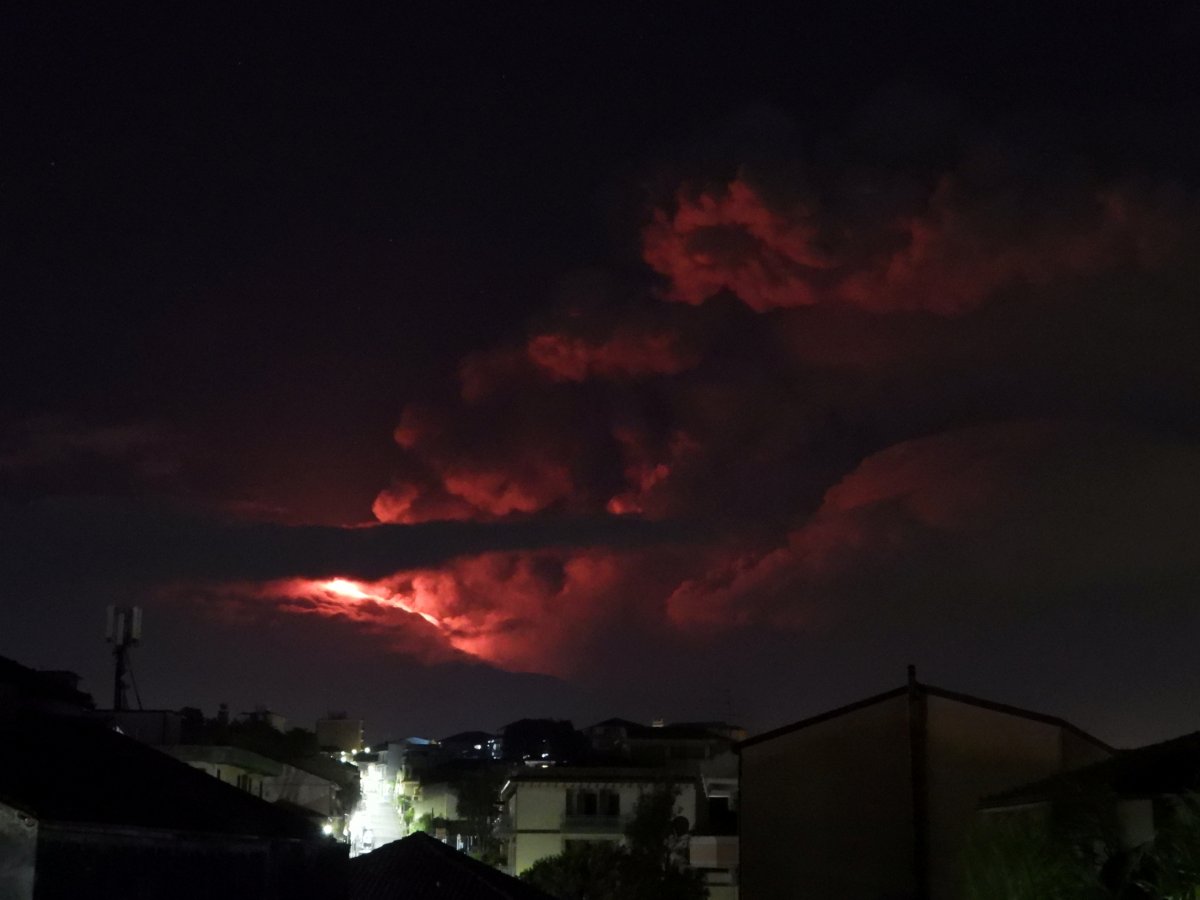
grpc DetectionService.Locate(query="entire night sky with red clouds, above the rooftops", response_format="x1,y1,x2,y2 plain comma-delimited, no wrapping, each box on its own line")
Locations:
0,2,1200,744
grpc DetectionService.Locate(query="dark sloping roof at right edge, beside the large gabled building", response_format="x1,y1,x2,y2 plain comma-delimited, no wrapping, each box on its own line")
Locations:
980,732,1200,809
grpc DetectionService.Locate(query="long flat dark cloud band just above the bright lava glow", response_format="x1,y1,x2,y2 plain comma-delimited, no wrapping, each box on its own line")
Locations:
0,499,668,589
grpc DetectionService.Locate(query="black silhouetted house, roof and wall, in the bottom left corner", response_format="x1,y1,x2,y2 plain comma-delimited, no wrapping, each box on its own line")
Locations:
0,704,346,900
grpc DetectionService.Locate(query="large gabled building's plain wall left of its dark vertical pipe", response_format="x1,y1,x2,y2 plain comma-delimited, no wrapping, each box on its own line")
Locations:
739,695,913,900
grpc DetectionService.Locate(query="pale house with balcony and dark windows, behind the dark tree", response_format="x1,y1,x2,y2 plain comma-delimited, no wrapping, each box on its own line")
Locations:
500,767,701,875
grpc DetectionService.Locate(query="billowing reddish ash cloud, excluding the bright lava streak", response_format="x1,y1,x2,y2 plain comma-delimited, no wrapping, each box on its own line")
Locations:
352,100,1200,673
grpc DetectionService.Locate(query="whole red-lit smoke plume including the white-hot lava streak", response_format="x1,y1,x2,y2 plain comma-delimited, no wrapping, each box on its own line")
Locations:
226,127,1200,674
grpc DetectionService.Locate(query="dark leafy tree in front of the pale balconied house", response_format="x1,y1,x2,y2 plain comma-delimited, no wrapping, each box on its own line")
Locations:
521,787,708,900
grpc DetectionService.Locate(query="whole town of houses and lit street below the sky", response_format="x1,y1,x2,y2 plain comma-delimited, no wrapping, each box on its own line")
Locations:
7,643,1200,900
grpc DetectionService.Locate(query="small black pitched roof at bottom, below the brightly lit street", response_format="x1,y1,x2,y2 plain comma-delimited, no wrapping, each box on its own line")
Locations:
349,832,553,900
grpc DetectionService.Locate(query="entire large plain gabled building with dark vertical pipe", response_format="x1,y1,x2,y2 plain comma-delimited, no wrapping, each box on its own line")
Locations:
739,670,1112,900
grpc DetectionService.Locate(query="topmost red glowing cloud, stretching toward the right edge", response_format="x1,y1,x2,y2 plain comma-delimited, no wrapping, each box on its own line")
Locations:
642,175,1175,314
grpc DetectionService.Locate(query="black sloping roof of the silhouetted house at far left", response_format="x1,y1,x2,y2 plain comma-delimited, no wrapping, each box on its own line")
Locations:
0,715,319,840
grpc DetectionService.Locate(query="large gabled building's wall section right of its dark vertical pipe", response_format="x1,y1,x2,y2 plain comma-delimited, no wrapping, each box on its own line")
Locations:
926,696,1104,900
